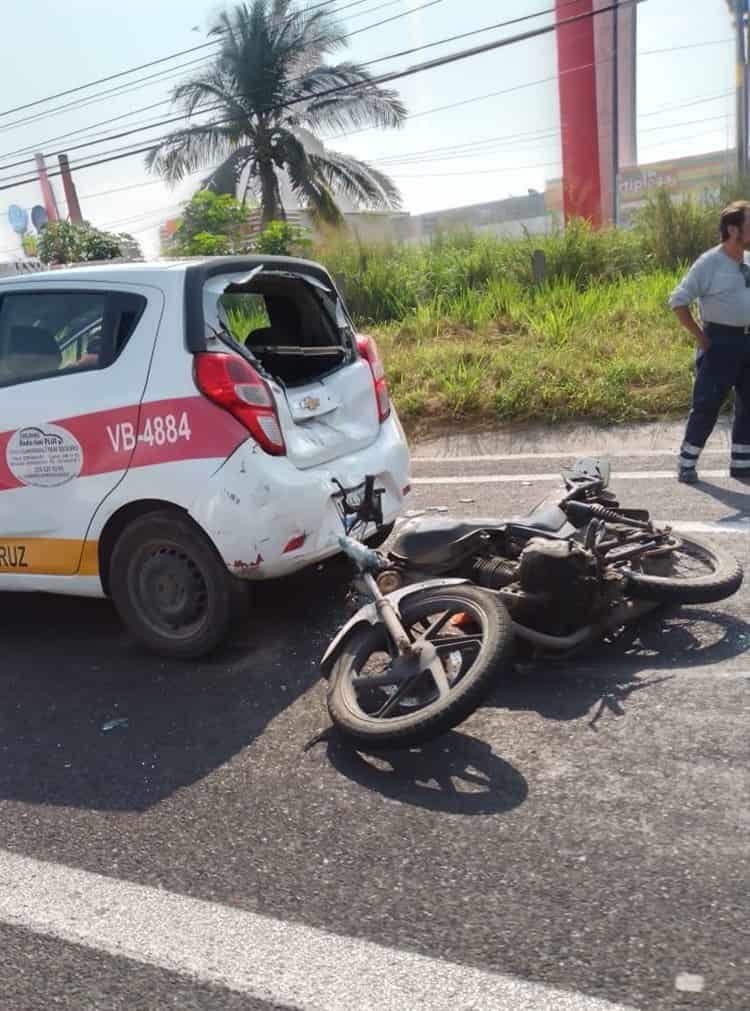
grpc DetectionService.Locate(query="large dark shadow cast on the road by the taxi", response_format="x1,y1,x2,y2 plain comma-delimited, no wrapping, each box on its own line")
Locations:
0,563,348,811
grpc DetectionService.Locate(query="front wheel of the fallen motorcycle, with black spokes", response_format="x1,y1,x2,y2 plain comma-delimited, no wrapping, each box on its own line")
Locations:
327,585,513,748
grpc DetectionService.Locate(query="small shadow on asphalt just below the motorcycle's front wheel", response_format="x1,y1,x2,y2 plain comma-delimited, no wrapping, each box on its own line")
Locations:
327,731,529,815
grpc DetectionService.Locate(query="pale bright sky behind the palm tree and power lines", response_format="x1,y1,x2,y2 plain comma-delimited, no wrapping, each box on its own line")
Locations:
0,0,734,253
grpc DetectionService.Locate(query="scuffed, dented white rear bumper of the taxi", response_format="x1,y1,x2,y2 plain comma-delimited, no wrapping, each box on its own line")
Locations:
190,411,410,579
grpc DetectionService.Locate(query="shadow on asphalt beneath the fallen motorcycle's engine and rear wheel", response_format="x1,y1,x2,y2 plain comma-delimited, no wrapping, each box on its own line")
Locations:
487,608,750,731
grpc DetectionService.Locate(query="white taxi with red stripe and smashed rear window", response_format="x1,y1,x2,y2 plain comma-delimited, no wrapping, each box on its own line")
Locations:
0,257,409,657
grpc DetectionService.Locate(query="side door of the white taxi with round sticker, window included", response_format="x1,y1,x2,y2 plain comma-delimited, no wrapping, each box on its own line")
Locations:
0,278,164,586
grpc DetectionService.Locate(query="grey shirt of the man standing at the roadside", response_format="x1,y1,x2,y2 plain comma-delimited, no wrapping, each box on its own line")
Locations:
669,246,750,327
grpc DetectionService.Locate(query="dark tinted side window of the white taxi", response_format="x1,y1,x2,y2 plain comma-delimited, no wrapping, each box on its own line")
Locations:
0,291,146,386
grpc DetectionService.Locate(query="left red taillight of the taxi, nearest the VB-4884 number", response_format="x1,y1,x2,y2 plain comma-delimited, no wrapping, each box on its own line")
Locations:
195,352,286,456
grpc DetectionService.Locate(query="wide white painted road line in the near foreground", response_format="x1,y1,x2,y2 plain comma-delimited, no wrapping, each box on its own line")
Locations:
0,850,634,1011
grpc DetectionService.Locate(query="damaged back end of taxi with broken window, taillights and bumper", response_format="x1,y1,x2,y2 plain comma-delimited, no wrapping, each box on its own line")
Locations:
186,258,410,647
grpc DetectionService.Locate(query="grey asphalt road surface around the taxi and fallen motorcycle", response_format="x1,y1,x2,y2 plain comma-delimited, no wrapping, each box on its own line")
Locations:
0,436,750,1011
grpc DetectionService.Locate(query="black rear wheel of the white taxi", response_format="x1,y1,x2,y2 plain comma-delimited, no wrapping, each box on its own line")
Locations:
109,510,248,659
